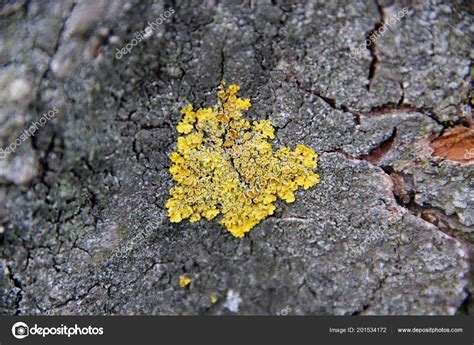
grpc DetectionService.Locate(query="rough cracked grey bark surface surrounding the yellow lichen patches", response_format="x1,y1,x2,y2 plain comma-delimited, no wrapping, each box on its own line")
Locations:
0,0,474,315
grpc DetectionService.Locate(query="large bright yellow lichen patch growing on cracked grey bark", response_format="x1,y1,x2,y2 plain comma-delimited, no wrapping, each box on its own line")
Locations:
166,85,319,236
